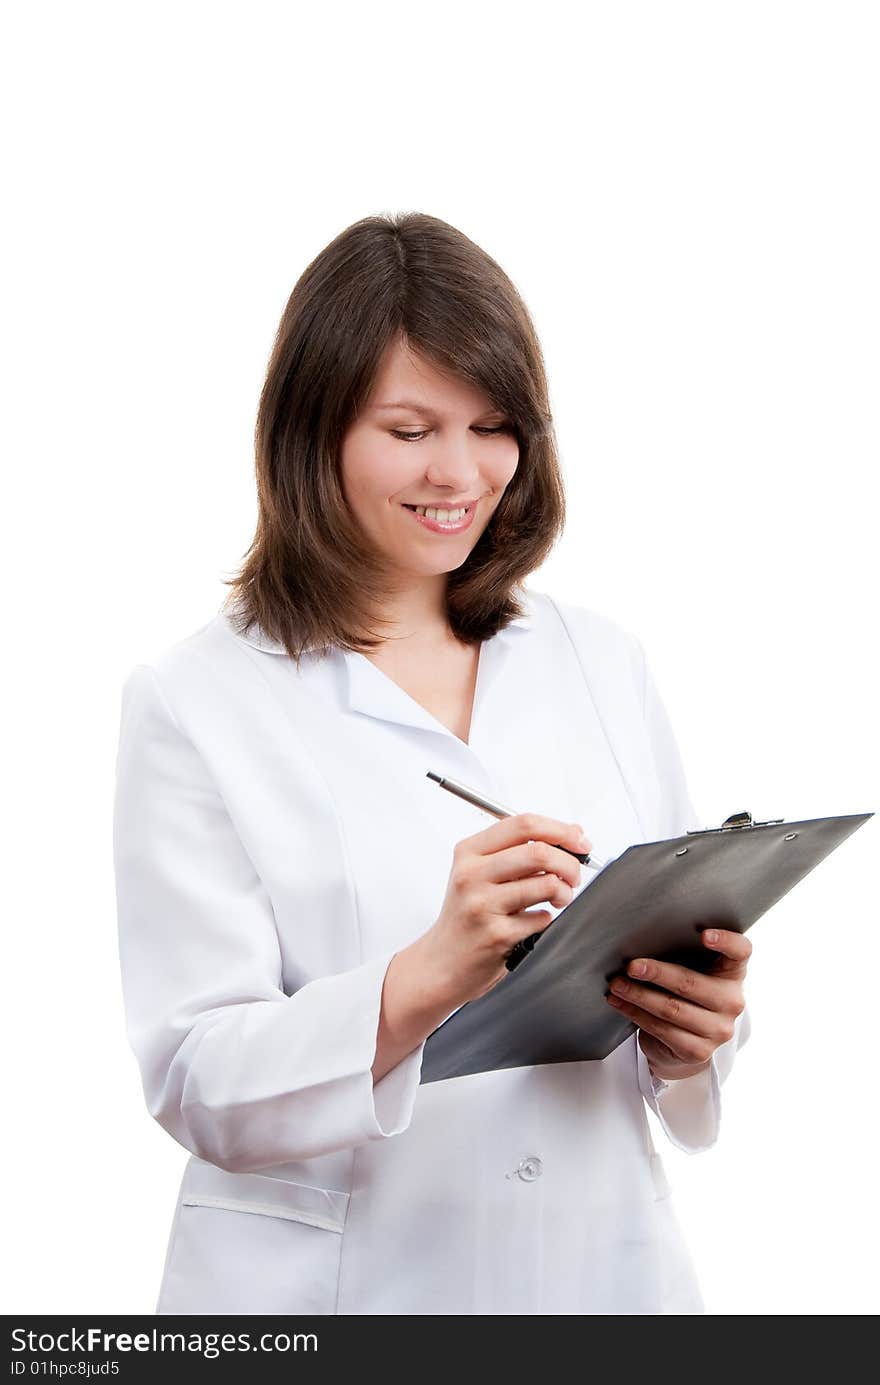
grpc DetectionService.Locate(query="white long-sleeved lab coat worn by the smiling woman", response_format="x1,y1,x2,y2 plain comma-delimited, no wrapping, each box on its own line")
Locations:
114,578,748,1314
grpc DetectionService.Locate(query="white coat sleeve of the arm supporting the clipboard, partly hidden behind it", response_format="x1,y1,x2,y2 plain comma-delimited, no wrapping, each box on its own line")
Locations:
636,640,751,1154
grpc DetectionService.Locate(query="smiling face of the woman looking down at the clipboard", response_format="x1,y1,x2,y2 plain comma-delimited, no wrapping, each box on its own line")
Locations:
335,342,520,578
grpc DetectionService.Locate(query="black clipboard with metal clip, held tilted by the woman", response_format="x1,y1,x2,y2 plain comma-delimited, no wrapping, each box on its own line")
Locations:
420,813,874,1083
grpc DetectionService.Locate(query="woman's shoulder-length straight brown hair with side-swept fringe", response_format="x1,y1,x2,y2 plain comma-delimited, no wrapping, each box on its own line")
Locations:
223,212,565,662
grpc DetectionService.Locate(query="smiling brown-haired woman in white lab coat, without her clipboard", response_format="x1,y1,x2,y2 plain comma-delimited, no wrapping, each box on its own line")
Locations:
114,215,750,1314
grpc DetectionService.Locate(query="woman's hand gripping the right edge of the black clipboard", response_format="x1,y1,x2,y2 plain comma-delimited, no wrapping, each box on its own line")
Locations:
606,928,751,1082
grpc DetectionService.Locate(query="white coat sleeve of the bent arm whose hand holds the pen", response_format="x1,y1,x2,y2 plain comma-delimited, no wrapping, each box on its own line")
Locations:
114,663,424,1172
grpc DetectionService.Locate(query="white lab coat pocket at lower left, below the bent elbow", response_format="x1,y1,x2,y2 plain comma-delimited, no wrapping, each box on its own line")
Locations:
157,1161,349,1314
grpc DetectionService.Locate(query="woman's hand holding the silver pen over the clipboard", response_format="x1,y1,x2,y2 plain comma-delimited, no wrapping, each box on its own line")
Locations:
420,813,592,1006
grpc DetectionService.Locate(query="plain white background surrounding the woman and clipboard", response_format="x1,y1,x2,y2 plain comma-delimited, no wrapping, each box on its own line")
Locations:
0,0,880,1314
